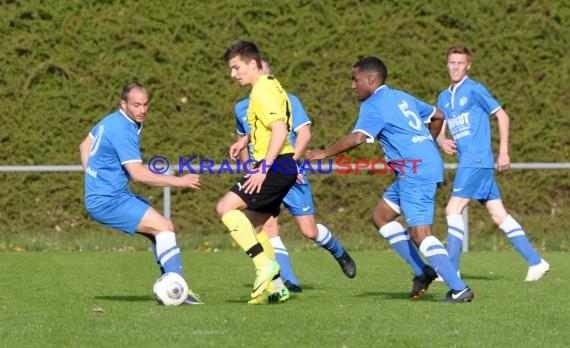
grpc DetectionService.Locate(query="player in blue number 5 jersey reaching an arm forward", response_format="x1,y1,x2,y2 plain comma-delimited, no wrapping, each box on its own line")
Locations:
306,57,473,303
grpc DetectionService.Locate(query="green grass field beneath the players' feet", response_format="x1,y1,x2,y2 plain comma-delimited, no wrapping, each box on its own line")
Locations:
0,250,570,347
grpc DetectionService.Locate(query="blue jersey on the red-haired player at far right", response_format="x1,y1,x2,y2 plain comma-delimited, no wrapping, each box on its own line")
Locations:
437,77,501,168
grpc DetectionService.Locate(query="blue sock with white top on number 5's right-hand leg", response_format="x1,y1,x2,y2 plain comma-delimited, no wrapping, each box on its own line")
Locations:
420,236,467,290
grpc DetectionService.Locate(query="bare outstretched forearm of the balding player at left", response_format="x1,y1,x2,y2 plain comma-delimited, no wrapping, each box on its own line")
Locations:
125,162,200,189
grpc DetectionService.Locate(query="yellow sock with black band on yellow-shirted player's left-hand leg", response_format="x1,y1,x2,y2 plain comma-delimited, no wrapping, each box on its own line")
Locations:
222,210,271,268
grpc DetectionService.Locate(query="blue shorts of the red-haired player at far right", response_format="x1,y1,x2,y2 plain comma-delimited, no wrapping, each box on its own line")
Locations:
451,167,501,204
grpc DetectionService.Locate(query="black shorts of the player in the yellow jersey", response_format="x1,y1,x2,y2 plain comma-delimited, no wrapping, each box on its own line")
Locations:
230,154,297,216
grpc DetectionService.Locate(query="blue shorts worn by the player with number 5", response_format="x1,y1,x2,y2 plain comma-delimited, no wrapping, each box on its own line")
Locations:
384,180,439,227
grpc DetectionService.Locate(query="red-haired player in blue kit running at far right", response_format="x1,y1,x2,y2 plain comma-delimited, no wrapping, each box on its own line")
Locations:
437,46,550,281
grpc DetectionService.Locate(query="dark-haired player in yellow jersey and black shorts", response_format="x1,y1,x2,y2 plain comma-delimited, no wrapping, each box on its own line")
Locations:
216,41,297,303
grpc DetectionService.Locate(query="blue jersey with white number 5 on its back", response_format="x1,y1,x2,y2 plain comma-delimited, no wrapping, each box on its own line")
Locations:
353,85,443,183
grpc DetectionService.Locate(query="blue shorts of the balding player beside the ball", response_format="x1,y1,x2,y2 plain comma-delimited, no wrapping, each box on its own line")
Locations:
86,192,150,235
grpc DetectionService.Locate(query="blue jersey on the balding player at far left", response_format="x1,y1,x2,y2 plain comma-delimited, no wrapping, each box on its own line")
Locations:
85,110,142,207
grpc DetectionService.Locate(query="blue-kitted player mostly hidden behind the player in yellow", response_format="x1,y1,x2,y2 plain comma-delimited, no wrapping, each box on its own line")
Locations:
234,61,356,292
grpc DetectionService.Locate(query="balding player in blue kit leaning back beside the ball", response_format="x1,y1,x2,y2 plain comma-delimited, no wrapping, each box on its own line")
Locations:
79,83,202,305
